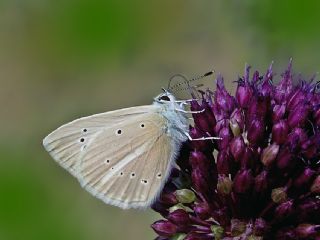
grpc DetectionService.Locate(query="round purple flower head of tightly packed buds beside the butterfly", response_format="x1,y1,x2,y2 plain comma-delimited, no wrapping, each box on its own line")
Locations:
152,61,320,240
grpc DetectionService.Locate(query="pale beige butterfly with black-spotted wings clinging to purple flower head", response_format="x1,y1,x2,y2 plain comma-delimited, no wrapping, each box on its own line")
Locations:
43,72,212,209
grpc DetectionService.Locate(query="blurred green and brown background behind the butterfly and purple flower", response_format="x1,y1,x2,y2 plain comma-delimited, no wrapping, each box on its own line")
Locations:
0,0,320,240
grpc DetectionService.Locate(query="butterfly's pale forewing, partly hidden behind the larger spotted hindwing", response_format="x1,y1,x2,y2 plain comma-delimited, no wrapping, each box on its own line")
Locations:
43,105,155,177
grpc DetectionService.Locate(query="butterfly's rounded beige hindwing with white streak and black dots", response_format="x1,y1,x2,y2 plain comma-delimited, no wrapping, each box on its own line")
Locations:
79,111,176,209
